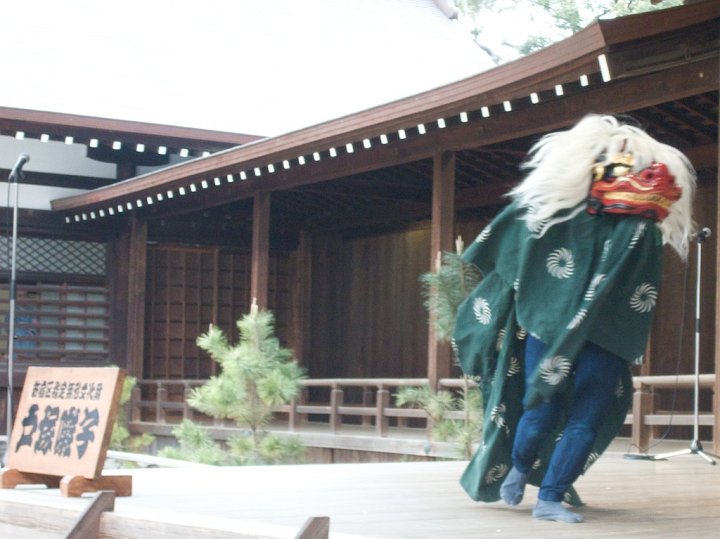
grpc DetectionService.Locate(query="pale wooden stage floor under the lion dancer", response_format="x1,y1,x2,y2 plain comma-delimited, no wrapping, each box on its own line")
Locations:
0,445,720,539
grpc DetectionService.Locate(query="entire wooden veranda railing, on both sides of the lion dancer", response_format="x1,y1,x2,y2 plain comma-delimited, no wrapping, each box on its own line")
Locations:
131,374,717,452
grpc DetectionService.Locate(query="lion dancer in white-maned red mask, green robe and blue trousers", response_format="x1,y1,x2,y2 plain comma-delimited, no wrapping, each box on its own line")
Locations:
453,115,695,522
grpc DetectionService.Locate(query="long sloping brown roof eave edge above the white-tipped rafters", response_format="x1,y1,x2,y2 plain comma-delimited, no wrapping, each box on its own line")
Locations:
52,2,720,217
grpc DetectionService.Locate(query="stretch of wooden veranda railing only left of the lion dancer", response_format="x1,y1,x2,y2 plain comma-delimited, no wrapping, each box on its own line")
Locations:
131,378,472,437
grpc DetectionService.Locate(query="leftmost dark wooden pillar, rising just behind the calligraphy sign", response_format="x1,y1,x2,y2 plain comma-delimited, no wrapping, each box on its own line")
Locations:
127,216,147,378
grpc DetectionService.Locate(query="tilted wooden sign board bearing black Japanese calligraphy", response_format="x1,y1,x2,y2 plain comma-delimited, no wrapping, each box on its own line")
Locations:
7,367,125,479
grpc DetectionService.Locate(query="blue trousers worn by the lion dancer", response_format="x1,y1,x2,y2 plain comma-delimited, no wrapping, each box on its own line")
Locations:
512,336,625,502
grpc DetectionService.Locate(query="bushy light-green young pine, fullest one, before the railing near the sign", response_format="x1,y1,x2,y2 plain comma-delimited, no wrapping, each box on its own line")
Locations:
163,302,304,464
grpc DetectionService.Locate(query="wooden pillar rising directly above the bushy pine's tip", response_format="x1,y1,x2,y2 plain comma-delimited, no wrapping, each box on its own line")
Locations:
250,192,270,309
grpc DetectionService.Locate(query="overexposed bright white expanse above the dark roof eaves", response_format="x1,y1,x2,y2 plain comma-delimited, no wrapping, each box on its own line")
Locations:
0,0,492,135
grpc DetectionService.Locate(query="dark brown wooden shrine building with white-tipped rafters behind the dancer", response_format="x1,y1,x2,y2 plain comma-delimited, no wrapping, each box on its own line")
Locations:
0,1,720,460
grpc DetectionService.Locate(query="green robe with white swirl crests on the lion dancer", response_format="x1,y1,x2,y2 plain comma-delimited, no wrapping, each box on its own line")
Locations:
453,203,662,505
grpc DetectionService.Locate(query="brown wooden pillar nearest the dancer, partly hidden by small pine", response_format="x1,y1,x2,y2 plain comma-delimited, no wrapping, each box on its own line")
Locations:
428,152,455,389
